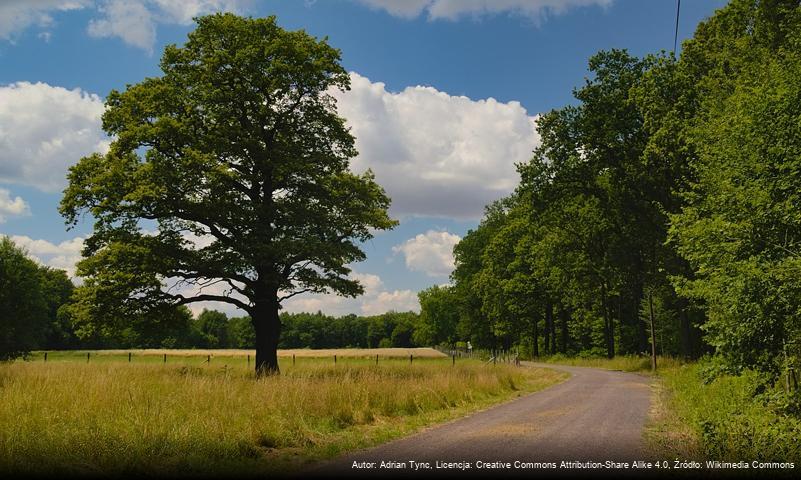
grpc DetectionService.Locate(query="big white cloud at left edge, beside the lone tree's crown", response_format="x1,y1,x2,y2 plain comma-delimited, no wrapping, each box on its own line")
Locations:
0,82,108,192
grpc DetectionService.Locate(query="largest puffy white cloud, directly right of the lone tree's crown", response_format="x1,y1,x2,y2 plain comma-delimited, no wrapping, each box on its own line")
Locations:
333,72,539,219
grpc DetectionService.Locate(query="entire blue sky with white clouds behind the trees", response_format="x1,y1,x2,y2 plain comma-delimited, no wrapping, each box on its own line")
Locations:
0,0,725,314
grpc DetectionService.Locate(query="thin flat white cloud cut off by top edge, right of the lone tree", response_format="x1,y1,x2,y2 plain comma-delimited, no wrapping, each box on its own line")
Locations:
357,0,613,22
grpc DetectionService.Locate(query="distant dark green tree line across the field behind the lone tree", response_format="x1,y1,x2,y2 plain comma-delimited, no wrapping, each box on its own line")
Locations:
0,237,429,354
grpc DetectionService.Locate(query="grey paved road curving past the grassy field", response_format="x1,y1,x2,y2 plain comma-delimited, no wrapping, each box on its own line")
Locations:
312,363,651,476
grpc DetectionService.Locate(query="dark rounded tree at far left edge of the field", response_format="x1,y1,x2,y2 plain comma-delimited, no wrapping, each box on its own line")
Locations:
0,237,49,361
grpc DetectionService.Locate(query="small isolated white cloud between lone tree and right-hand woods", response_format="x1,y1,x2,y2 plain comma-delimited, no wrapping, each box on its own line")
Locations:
392,230,462,277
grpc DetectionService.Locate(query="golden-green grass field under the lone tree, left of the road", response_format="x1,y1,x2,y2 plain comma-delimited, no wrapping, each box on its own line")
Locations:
0,351,565,475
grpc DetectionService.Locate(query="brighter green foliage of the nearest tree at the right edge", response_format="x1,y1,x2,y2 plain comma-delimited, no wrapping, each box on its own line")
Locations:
671,1,801,376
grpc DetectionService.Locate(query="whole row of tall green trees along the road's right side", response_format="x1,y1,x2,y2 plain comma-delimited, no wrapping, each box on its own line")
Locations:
420,0,801,382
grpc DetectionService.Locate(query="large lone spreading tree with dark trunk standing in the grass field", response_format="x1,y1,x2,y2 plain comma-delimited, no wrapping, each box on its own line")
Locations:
60,14,397,374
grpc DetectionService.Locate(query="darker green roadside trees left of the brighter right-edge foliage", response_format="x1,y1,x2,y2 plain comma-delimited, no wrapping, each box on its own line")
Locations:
446,50,690,357
